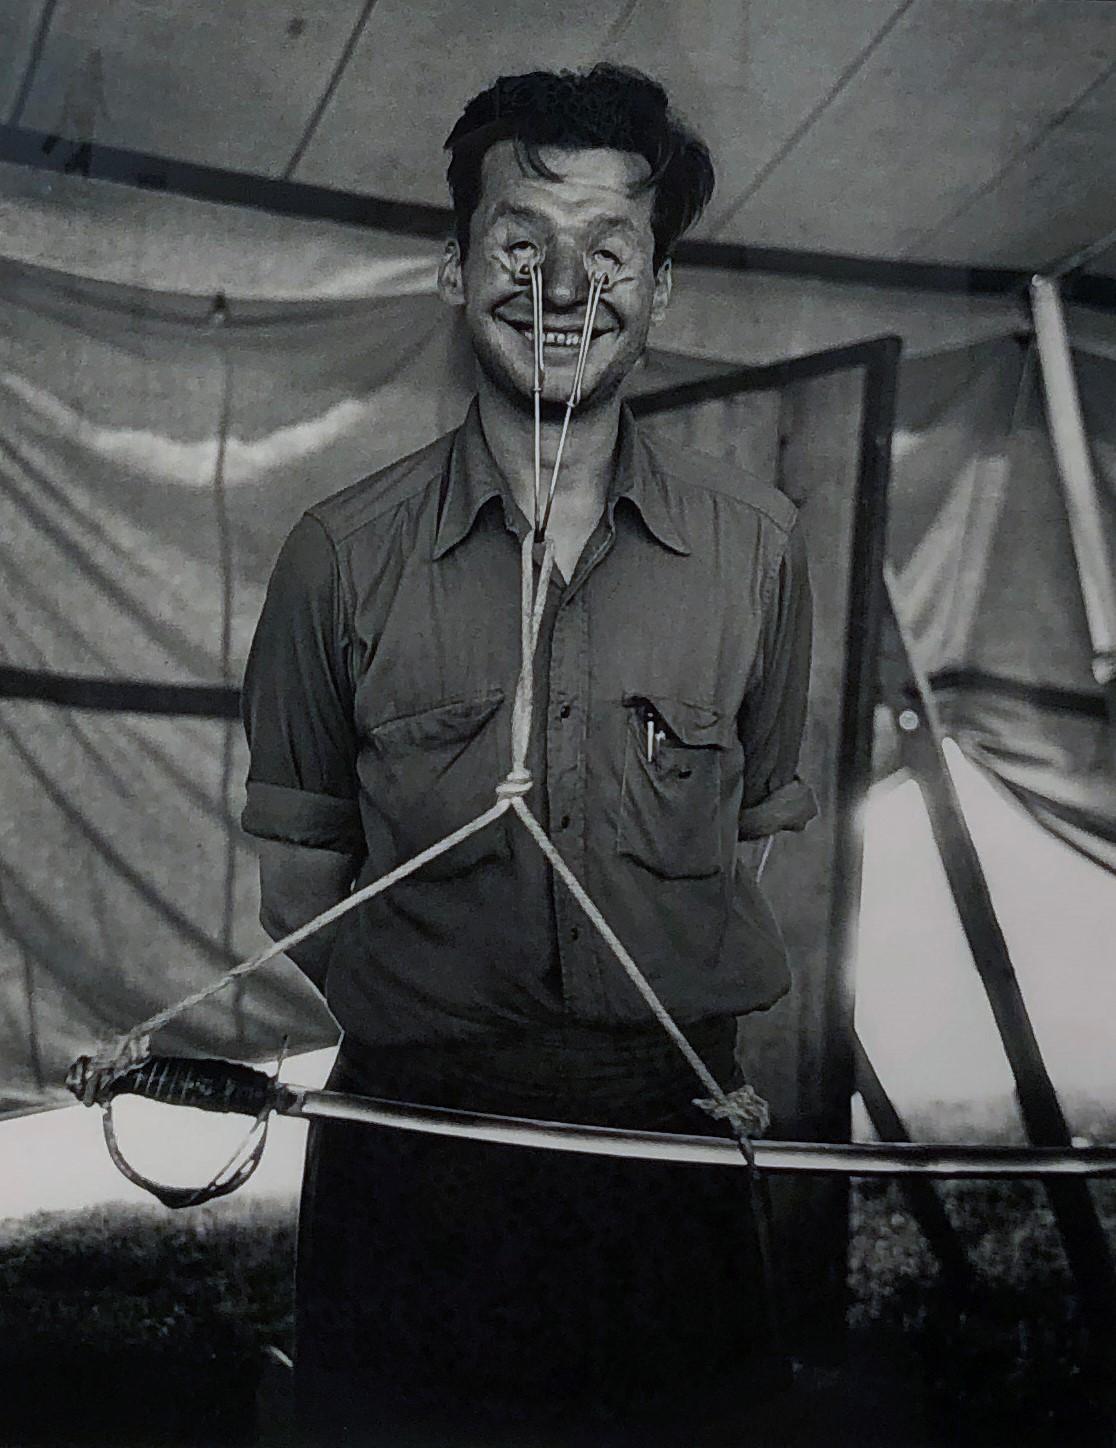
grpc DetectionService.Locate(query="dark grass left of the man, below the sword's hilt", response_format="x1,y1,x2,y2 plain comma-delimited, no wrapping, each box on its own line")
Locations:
0,1200,294,1448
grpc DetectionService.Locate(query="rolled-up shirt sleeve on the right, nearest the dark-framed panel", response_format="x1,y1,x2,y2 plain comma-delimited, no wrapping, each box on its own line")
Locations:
737,521,818,840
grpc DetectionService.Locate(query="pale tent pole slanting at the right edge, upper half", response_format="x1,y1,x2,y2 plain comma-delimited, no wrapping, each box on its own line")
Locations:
1031,277,1116,727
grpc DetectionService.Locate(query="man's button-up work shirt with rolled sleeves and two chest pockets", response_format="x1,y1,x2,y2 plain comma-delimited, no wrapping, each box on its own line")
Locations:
243,404,813,1044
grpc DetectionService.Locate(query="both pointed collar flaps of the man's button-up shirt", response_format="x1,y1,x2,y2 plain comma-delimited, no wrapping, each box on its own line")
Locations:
431,398,690,560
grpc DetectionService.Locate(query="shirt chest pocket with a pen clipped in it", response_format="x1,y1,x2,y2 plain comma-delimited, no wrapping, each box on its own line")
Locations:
617,694,732,879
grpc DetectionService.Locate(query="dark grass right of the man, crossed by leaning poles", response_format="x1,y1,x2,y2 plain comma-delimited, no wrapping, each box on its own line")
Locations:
850,1182,1116,1448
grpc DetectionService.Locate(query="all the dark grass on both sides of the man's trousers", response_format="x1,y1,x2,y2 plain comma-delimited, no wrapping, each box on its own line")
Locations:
0,1183,1116,1448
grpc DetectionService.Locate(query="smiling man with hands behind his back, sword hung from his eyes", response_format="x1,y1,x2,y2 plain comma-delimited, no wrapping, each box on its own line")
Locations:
245,65,813,1445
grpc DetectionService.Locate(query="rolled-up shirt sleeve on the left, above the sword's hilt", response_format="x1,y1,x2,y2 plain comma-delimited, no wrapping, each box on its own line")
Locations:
240,514,365,854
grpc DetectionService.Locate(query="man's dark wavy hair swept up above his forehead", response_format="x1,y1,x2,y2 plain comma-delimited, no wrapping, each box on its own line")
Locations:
446,62,714,269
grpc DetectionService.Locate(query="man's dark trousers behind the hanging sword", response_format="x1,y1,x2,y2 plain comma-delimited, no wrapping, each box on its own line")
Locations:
295,1022,767,1448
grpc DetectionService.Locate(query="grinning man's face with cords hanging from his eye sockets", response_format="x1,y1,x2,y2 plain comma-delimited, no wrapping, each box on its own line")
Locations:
441,140,670,413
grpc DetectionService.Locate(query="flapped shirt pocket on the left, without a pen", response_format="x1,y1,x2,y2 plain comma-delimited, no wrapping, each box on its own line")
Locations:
368,689,510,880
